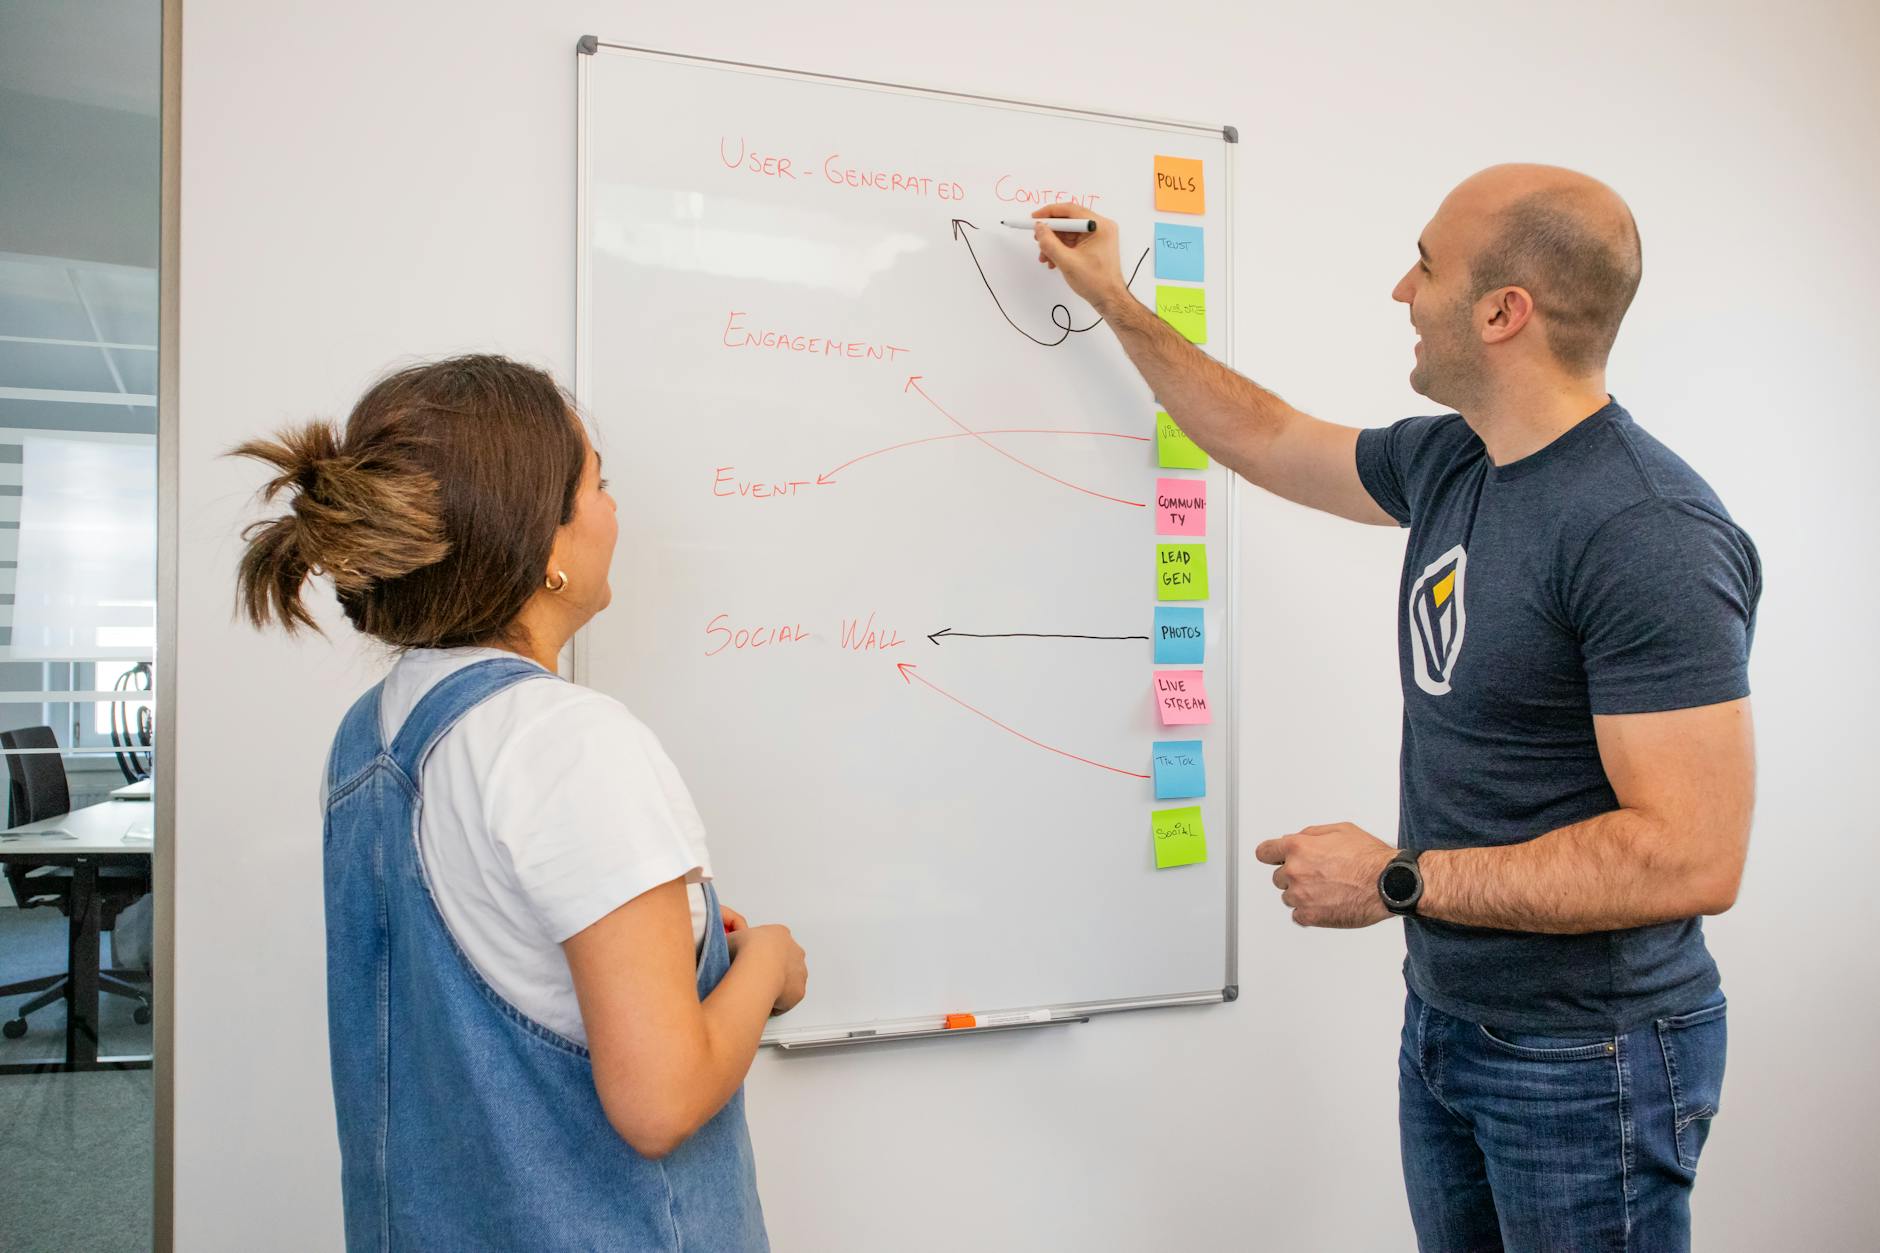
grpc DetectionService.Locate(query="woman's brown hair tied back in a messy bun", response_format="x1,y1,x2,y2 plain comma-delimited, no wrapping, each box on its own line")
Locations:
229,356,587,649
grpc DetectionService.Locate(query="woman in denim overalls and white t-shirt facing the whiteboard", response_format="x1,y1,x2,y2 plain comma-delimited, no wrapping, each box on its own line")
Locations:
235,356,807,1249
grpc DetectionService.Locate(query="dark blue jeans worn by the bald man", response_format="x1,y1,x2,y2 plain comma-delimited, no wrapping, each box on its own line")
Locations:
1397,991,1726,1253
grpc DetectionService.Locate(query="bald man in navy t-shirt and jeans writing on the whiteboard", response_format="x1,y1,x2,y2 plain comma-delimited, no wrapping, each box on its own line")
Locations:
1034,166,1762,1253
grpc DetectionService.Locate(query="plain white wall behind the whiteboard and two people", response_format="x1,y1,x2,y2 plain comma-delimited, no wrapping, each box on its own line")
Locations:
175,0,1880,1253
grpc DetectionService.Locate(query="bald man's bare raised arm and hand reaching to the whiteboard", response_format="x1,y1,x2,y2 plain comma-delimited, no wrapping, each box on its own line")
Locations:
1032,203,1397,527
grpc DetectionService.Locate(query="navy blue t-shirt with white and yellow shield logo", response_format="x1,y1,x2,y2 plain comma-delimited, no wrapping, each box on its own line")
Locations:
1357,401,1762,1035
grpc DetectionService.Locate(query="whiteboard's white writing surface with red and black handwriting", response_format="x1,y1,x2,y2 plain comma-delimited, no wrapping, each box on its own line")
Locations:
575,40,1237,1046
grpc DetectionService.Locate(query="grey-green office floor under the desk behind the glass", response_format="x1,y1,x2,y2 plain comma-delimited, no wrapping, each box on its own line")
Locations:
0,909,152,1253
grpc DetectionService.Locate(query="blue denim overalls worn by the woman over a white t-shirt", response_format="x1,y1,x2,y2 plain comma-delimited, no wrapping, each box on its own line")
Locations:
325,658,769,1253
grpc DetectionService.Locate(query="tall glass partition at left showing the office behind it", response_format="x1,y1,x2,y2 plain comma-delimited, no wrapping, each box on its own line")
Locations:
0,0,162,1249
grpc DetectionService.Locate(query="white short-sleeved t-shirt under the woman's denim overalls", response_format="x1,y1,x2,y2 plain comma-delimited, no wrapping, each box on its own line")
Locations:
380,649,711,1044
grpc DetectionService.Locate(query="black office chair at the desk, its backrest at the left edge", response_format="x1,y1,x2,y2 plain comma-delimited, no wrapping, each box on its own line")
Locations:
0,726,150,1040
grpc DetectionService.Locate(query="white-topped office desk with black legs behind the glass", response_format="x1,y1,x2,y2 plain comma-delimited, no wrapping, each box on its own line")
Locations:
0,801,154,1074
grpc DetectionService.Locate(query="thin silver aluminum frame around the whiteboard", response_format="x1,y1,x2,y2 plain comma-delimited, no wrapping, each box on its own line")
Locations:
572,36,1241,1052
